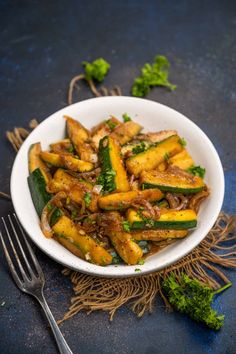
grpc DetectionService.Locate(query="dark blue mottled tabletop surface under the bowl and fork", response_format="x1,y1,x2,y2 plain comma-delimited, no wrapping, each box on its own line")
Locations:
0,0,236,354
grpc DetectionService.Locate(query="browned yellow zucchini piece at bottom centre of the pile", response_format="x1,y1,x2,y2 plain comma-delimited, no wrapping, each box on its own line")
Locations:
108,231,143,265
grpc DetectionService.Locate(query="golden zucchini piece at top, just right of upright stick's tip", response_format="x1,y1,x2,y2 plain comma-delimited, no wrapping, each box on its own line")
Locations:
111,120,142,145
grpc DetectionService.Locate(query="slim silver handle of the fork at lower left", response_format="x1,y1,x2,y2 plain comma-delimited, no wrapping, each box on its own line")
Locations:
37,293,73,354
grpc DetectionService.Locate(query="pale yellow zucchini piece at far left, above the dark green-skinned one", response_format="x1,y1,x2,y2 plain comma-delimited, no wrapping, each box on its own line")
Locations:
28,143,51,183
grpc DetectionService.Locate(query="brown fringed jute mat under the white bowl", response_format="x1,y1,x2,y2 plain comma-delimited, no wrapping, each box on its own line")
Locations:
0,75,236,323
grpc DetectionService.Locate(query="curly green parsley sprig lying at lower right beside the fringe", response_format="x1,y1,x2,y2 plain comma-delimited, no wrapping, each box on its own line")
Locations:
163,273,232,331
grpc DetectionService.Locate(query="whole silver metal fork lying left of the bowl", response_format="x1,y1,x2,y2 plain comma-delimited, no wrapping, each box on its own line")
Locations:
0,213,73,354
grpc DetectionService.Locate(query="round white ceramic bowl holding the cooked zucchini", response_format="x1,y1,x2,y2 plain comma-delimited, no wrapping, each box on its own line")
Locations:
11,97,224,277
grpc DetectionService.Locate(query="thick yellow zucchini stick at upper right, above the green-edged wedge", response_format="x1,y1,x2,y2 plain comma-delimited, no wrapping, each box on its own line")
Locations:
126,135,183,177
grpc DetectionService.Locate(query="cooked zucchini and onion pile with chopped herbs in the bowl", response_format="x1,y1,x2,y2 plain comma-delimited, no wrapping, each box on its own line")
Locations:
28,114,209,266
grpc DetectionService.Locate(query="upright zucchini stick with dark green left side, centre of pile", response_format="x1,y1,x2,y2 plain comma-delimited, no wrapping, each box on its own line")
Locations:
98,136,130,192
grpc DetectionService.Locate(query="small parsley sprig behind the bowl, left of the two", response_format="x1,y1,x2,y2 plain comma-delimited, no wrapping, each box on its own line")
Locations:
82,58,110,82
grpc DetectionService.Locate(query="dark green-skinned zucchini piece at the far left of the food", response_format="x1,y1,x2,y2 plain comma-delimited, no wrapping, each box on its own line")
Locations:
28,168,52,217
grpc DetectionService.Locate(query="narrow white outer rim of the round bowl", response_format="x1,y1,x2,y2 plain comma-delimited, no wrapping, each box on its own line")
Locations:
10,96,225,278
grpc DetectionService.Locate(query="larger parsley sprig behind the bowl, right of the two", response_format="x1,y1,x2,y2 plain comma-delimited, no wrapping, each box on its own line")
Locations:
131,55,176,97
